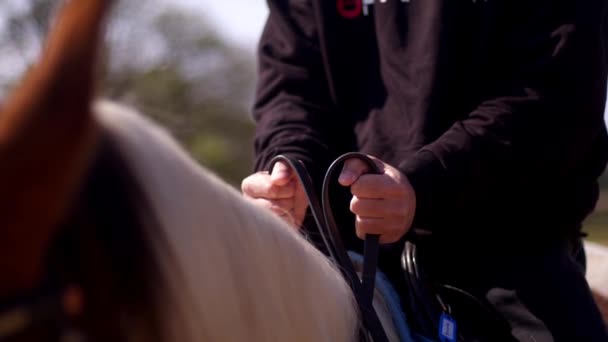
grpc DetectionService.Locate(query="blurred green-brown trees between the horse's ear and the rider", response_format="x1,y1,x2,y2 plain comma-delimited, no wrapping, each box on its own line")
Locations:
105,1,254,185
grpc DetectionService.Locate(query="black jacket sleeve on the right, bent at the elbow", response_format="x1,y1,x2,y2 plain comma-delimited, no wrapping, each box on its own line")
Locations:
400,0,606,232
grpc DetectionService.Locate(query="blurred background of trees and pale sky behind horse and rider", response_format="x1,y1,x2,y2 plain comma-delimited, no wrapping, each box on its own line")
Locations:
0,0,608,245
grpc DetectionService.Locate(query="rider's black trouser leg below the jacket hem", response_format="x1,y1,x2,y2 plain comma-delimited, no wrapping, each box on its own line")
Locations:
404,239,608,342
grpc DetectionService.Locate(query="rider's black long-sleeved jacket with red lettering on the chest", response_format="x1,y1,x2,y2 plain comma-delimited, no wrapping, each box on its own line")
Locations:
254,0,608,250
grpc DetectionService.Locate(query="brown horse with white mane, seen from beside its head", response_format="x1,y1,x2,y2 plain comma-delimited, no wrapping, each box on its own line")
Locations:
0,0,408,342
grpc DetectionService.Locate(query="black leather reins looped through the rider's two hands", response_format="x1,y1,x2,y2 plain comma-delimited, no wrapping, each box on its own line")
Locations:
269,152,388,342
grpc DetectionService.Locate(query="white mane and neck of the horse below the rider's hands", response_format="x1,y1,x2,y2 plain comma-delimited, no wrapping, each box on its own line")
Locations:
94,101,359,342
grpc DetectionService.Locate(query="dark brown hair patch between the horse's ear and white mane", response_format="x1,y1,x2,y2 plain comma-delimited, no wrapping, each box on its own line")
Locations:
44,135,165,342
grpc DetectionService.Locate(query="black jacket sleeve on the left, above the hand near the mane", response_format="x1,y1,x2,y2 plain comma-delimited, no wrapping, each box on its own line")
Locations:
253,0,345,178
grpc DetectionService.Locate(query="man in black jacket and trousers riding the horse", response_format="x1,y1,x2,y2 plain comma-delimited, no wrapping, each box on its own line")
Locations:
242,0,608,341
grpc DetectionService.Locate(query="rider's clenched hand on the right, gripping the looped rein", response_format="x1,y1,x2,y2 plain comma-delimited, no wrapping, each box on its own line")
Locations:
338,156,416,243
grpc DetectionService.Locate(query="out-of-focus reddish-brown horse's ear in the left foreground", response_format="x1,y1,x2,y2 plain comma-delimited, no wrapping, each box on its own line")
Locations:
0,0,112,295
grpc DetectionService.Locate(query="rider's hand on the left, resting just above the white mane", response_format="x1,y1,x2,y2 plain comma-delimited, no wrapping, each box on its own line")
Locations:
241,161,308,228
